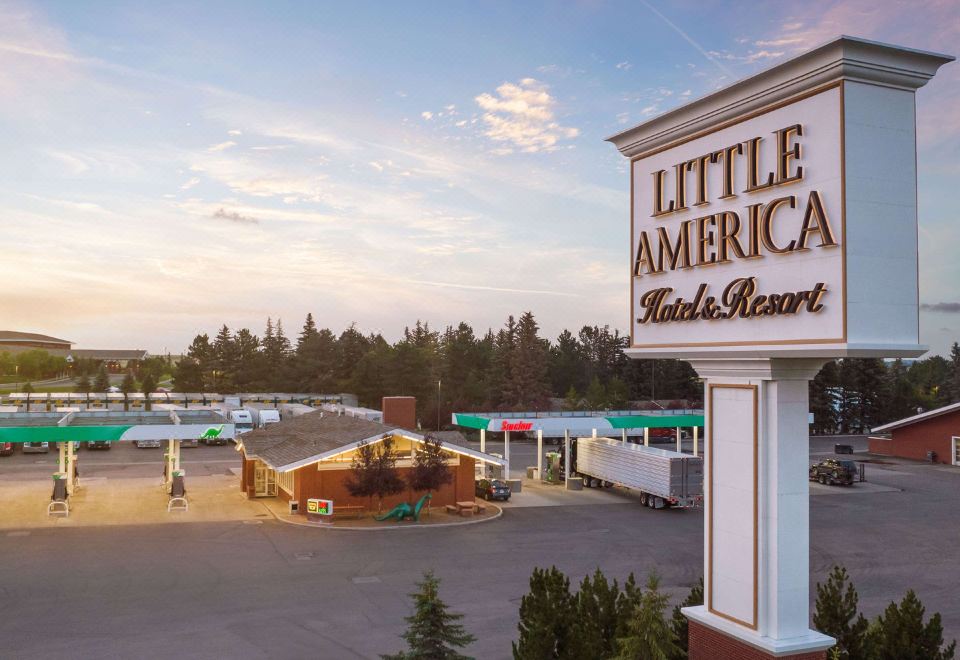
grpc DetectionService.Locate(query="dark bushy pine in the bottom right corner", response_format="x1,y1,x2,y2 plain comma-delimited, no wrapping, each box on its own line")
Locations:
868,589,957,660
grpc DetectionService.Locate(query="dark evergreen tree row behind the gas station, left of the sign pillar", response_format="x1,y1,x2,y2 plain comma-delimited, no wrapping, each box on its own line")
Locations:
174,312,703,420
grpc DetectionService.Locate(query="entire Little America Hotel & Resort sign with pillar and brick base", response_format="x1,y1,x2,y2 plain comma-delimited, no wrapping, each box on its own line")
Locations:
609,37,954,660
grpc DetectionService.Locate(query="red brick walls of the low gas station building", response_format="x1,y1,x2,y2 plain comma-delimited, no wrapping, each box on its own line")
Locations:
293,456,474,513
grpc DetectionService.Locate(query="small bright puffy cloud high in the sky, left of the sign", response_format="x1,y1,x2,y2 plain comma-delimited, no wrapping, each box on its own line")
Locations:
474,78,580,154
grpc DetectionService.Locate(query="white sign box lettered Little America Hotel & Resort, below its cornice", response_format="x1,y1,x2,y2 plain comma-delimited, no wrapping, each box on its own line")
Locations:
618,82,922,357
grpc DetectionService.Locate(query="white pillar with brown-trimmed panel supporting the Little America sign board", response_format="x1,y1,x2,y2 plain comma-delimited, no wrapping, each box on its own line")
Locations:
684,358,833,655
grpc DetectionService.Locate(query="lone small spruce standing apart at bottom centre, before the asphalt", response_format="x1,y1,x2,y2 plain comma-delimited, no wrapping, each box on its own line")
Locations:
380,571,476,660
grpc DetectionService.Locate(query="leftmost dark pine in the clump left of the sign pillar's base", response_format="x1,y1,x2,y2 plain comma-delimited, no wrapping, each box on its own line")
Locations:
513,566,577,660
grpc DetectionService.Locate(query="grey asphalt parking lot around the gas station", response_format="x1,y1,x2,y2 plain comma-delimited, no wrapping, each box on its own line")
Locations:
0,438,960,658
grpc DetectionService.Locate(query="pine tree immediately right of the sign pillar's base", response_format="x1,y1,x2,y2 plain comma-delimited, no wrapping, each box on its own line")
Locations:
813,566,868,660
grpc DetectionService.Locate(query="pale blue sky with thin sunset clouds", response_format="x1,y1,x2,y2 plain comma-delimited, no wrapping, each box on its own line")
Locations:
0,0,960,353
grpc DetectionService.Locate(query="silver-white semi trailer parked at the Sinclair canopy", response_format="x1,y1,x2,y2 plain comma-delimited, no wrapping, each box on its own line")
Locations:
572,438,703,509
